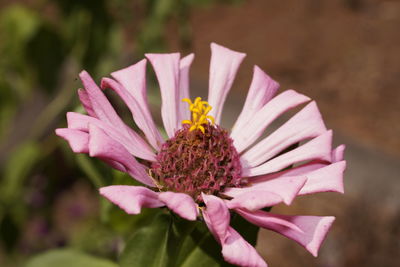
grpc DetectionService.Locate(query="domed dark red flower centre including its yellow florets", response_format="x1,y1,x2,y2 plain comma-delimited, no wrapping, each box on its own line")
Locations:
151,98,242,201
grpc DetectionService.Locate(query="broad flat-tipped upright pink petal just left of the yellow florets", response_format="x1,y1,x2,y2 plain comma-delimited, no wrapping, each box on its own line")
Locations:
146,53,180,138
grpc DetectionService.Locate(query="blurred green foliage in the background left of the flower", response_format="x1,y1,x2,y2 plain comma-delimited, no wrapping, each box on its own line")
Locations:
0,0,244,266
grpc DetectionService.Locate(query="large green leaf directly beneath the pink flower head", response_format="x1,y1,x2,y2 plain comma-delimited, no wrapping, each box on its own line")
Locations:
120,213,259,267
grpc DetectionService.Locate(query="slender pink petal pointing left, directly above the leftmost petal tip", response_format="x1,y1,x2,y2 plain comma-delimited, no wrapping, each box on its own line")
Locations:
67,112,155,161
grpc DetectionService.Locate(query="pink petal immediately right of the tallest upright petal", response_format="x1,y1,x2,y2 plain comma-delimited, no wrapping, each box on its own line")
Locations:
231,66,279,135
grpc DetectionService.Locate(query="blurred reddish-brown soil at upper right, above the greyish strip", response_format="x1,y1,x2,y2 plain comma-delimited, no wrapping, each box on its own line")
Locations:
171,0,400,159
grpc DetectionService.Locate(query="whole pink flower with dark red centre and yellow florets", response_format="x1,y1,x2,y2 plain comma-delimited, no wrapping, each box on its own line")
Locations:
56,43,346,266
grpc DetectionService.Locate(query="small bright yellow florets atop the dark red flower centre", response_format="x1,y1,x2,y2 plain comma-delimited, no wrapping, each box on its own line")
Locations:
182,97,215,134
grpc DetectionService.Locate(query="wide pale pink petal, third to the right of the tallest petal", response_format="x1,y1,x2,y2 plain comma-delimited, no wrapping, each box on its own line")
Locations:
241,101,326,167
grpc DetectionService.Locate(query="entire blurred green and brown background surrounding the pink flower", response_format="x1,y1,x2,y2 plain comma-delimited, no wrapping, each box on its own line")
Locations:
0,0,400,267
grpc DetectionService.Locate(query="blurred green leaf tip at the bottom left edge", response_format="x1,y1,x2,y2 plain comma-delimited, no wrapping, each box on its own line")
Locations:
25,249,118,267
